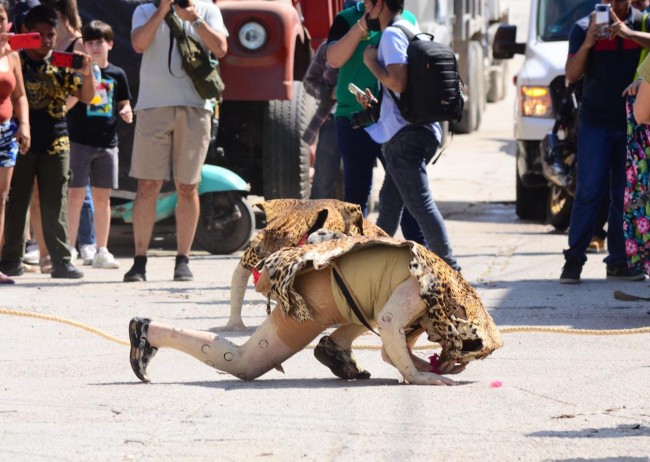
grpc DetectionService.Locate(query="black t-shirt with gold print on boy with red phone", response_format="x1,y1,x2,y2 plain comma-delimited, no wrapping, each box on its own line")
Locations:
20,51,83,155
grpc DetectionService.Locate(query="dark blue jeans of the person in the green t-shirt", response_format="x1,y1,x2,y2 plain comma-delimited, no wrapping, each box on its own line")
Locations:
336,117,381,217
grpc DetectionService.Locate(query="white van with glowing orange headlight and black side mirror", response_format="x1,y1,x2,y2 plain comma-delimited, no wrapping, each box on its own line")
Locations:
493,0,600,220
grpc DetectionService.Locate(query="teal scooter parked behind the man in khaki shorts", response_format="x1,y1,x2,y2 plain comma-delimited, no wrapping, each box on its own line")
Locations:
111,164,255,255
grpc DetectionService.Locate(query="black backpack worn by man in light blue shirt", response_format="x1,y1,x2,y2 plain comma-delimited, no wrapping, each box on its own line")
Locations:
389,24,464,125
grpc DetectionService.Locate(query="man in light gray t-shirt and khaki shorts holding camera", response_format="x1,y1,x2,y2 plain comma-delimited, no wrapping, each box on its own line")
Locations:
124,0,228,282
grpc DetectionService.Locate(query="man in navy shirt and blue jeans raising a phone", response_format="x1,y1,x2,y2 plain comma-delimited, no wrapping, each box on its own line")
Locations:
560,0,650,284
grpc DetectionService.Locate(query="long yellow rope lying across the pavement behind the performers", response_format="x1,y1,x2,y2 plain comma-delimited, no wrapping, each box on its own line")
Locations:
0,308,650,350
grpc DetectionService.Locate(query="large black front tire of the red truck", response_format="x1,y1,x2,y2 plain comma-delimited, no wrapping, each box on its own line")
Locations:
262,82,316,200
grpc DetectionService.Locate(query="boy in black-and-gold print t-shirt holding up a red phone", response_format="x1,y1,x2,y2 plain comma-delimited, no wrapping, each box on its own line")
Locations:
0,5,95,279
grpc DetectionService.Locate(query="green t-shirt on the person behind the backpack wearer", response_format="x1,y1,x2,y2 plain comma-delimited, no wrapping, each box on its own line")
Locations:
327,2,417,119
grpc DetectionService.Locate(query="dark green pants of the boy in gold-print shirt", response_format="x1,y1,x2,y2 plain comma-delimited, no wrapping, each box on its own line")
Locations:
2,152,70,262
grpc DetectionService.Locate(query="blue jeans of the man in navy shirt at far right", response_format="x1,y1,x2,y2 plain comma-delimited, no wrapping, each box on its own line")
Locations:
564,122,627,266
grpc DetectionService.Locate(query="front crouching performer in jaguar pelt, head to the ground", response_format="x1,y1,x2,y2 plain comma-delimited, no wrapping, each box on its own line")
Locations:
129,233,502,385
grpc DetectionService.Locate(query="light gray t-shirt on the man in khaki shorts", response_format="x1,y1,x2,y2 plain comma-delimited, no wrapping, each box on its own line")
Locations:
131,0,228,111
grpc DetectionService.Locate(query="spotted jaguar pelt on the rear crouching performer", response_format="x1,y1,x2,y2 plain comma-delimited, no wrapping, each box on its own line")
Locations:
241,199,388,270
